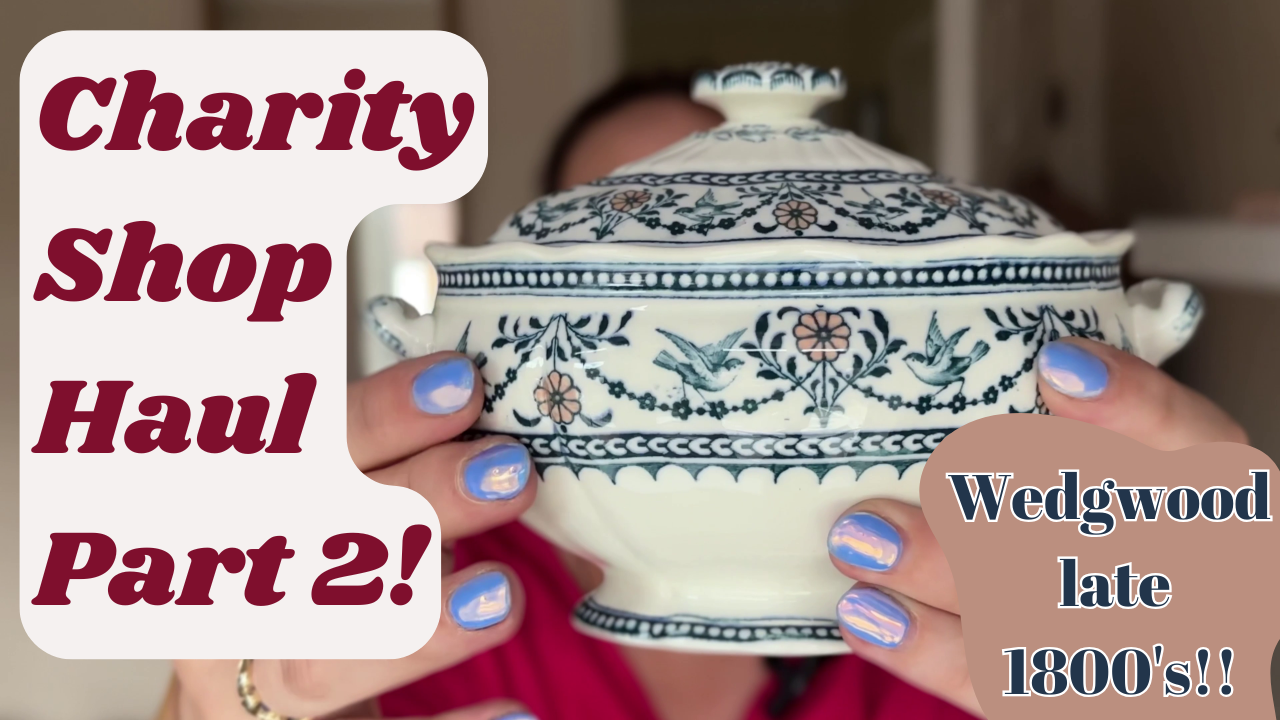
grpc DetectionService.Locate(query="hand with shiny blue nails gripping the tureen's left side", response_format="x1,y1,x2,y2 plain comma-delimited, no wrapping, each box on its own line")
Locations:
168,352,538,720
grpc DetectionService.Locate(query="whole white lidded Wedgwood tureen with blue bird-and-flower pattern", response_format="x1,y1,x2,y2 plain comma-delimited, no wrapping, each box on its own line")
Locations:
370,63,1201,655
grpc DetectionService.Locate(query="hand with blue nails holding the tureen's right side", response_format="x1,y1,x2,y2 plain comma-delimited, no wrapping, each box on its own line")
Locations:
828,338,1248,715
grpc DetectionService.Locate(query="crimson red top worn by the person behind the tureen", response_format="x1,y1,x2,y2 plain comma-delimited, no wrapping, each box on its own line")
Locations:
380,523,970,720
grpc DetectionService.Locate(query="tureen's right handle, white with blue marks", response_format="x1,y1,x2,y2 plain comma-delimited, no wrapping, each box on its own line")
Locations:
1125,275,1204,365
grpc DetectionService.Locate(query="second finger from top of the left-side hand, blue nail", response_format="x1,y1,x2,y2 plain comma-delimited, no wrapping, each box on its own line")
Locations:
369,437,538,541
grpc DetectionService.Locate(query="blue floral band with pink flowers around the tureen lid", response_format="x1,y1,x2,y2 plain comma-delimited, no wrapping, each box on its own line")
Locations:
498,170,1061,245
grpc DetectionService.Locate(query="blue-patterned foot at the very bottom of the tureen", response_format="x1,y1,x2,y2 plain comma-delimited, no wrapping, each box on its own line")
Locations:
573,593,849,657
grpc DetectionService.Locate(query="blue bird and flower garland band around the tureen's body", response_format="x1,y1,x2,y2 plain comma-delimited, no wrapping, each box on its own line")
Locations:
458,304,1108,432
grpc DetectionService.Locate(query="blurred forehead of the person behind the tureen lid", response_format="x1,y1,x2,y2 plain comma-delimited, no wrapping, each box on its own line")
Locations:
557,95,723,190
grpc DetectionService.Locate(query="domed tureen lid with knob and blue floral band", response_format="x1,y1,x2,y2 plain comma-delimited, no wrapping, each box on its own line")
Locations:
493,63,1062,246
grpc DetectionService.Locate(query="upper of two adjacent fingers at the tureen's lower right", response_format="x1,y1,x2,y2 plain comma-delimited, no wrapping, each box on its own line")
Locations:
827,500,960,614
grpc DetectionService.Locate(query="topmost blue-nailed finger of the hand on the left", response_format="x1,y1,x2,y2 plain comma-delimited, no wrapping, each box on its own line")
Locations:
347,352,484,470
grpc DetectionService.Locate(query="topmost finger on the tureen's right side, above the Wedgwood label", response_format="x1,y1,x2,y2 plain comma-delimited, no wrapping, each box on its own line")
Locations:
1037,338,1248,450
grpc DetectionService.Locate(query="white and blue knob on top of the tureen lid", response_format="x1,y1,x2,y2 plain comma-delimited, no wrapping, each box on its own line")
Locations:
692,63,845,123
